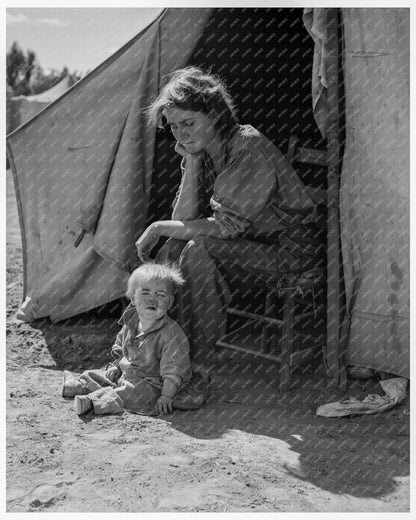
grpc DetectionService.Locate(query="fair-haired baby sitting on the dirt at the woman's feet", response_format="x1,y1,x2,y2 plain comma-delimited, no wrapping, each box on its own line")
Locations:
62,263,209,415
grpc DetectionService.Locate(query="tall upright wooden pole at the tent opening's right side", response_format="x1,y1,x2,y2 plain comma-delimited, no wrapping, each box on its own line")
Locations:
327,8,343,385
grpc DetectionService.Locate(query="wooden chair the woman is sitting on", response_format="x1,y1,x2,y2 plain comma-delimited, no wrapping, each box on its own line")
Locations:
217,136,327,391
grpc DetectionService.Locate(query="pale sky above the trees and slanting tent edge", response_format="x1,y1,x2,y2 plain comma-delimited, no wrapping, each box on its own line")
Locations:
6,7,162,73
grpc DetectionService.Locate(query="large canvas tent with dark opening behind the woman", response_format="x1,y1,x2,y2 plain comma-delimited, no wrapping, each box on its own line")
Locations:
7,8,409,384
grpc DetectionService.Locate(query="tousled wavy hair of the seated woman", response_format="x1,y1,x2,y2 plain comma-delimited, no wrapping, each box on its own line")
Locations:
146,66,237,136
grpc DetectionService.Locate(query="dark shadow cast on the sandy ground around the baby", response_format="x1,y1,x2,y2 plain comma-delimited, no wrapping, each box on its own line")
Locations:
31,309,409,498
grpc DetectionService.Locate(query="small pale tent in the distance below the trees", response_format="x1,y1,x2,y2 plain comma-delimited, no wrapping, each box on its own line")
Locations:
6,75,75,133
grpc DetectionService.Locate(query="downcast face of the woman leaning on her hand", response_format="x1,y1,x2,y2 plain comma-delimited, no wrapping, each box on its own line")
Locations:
163,108,217,153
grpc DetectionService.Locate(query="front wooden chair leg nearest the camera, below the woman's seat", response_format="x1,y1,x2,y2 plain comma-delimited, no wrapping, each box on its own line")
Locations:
279,291,295,391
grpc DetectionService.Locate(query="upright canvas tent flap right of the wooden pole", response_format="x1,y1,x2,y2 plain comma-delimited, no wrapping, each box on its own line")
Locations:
340,9,410,377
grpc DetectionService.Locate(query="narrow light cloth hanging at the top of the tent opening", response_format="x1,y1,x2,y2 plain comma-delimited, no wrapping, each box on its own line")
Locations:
303,7,328,137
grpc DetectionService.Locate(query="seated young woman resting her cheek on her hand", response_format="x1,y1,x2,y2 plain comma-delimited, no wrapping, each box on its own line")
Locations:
136,67,322,360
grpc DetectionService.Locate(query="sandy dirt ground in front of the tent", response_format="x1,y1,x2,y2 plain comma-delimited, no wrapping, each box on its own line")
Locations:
6,171,410,513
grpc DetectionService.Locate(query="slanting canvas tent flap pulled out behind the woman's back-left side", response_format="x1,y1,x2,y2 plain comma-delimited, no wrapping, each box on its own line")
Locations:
7,9,211,321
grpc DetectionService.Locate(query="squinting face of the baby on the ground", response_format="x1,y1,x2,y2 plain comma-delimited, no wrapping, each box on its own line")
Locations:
133,279,173,321
